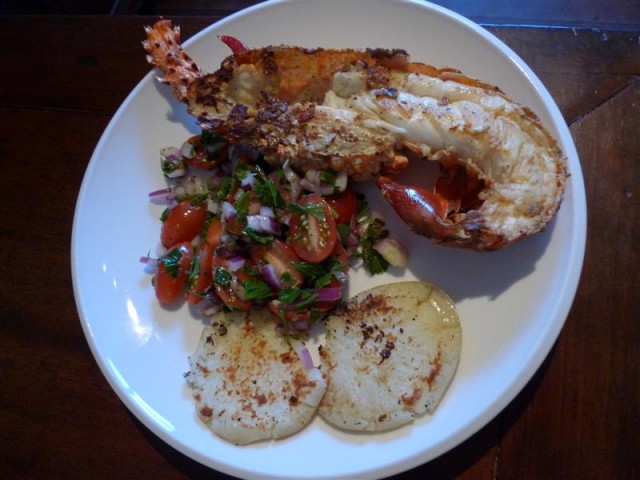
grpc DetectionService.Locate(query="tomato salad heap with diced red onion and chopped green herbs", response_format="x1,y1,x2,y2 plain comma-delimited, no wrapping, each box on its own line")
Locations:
141,131,407,334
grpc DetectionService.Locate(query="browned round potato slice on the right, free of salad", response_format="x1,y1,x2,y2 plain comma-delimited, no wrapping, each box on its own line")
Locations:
319,281,462,431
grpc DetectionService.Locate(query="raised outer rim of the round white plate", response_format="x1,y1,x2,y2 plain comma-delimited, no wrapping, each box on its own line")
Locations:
71,0,587,478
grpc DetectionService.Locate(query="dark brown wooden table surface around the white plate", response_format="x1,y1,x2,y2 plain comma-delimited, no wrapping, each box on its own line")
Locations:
0,6,640,479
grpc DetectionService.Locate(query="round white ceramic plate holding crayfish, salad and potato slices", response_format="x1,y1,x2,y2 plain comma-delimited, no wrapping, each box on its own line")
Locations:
72,1,586,479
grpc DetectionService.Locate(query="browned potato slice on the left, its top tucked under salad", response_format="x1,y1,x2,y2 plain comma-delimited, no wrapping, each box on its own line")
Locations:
186,309,326,445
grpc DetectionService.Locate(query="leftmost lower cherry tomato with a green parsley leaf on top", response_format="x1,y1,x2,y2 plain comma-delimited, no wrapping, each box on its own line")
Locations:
153,242,193,305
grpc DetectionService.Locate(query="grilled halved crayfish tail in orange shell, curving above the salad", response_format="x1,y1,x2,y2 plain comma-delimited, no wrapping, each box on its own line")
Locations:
143,20,568,251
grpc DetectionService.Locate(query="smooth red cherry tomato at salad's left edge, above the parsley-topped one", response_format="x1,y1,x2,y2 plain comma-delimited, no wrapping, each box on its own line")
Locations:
160,200,207,248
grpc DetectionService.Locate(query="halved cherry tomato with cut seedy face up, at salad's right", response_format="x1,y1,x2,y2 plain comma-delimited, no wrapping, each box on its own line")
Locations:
289,193,338,263
